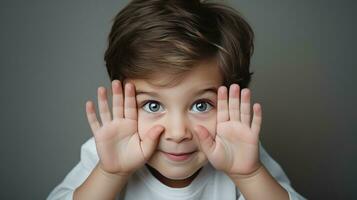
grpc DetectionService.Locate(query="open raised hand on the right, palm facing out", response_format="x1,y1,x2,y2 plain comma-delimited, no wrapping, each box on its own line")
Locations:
194,84,262,177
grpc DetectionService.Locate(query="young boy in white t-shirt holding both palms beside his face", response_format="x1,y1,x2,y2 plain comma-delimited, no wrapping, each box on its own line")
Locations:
48,0,304,200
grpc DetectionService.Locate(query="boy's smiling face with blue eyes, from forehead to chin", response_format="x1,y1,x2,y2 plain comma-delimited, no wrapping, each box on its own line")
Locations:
128,61,223,183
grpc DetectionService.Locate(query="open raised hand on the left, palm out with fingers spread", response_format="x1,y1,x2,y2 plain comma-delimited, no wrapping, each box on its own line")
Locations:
86,80,164,175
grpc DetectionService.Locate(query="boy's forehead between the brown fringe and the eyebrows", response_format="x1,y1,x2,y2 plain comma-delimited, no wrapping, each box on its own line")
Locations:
127,60,223,93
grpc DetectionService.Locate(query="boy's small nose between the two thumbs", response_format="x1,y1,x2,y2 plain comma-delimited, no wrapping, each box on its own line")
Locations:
163,115,193,143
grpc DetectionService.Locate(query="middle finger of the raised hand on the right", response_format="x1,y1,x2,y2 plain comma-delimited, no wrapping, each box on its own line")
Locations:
228,84,240,121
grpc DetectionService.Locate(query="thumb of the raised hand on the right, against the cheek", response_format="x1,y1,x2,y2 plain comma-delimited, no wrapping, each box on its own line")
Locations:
194,125,216,157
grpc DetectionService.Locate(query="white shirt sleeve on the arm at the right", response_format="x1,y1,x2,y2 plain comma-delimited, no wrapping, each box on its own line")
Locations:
237,143,305,200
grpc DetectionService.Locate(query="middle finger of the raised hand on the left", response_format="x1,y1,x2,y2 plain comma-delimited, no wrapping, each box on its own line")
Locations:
112,80,124,119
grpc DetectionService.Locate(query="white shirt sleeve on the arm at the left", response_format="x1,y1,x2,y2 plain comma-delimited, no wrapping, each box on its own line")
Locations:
47,137,99,200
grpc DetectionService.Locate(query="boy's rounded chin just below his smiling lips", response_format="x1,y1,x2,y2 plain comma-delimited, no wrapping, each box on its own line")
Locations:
148,152,208,180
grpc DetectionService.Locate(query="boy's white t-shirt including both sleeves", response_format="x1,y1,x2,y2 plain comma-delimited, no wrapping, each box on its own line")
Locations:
47,137,305,200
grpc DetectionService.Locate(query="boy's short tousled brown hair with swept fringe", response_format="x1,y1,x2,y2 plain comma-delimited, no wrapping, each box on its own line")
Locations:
104,0,254,89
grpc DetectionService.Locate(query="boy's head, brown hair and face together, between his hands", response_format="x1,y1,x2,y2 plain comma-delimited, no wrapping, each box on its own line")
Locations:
105,0,253,186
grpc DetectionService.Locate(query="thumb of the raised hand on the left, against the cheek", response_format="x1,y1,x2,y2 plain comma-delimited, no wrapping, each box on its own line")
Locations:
140,125,164,160
